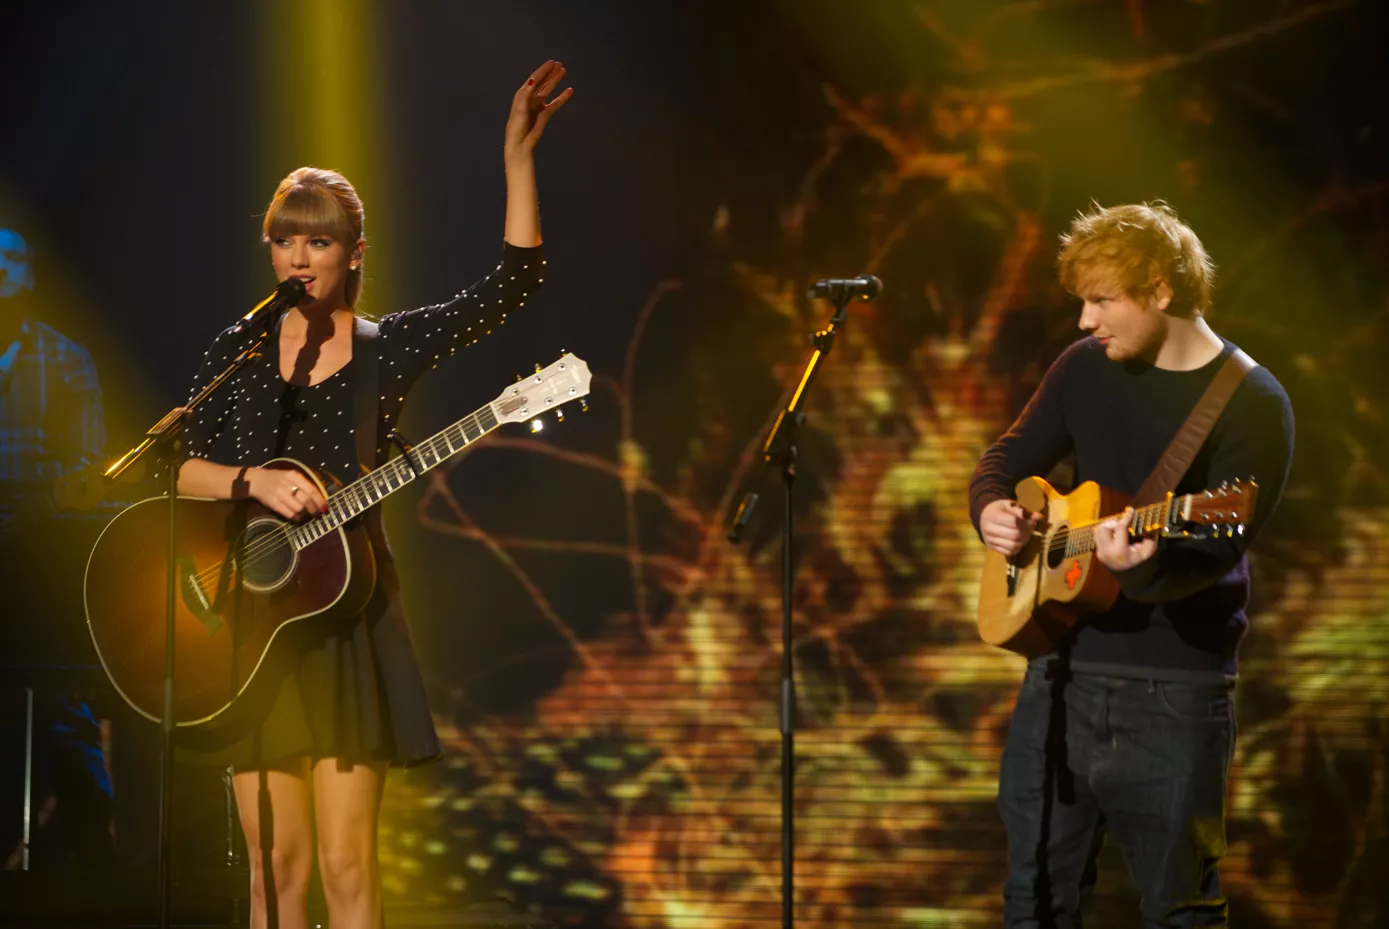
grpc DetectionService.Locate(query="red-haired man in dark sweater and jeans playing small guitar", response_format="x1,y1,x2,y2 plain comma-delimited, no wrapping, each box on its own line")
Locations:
970,203,1293,929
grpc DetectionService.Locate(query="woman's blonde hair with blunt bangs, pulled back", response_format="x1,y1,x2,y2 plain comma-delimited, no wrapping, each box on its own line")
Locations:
261,168,367,307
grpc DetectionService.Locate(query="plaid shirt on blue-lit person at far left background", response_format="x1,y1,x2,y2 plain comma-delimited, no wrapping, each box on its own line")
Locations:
0,319,106,482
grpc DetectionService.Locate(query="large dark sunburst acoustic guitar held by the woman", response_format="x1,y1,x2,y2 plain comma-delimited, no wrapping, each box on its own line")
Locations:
85,354,592,730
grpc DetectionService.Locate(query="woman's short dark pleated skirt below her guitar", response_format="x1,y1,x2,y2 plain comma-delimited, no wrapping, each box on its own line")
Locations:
178,550,440,771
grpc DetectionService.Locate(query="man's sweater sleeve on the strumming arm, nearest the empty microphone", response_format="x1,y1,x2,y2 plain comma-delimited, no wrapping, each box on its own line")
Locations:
970,339,1085,532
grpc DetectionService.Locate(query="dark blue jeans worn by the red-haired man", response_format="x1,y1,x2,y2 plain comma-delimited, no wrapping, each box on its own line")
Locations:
999,667,1235,929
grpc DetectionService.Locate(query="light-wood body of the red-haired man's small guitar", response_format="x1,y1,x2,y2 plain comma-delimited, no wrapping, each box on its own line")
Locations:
978,478,1126,658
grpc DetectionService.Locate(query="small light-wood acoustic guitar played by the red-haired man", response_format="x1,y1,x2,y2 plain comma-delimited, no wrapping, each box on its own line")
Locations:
978,478,1258,658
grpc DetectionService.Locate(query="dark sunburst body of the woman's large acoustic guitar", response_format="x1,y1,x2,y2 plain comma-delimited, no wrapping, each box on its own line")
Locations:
85,458,376,729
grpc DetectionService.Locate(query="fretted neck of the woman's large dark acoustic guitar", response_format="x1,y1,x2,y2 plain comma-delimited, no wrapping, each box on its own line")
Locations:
289,403,499,550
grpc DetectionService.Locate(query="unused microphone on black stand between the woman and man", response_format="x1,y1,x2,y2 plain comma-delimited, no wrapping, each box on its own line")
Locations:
728,275,882,929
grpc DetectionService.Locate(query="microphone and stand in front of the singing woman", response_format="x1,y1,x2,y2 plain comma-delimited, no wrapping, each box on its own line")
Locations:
101,305,290,929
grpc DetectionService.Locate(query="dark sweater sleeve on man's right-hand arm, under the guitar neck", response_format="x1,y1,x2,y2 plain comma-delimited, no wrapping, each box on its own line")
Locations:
1114,369,1293,603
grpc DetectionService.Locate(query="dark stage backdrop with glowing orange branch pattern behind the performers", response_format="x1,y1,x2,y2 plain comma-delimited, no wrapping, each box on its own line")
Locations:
0,0,1389,929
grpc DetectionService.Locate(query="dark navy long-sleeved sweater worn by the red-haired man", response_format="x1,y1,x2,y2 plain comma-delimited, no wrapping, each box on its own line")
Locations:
970,339,1293,680
